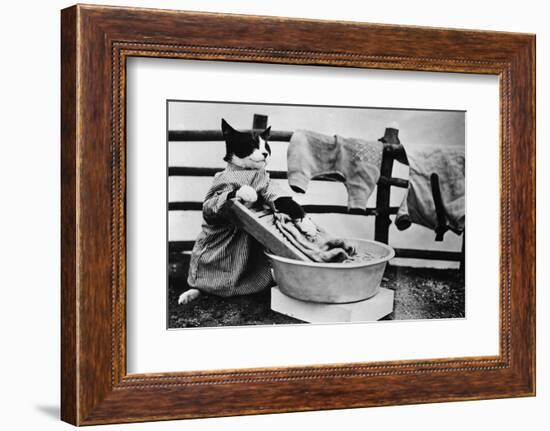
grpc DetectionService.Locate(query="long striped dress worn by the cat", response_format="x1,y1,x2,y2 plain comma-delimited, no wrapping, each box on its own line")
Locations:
187,163,281,296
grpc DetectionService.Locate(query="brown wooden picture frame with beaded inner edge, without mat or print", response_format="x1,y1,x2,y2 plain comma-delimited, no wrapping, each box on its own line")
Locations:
61,5,535,425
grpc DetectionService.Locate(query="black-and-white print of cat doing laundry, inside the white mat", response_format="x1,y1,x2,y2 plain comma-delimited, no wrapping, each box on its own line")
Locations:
167,100,466,329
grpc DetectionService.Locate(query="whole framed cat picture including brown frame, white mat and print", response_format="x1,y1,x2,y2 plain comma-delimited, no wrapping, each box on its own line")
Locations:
61,5,535,425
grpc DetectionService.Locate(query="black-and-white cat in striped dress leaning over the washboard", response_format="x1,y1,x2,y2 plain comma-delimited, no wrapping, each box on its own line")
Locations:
178,118,316,304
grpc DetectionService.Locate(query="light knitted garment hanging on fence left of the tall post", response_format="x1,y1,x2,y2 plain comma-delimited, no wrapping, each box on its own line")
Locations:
287,130,384,210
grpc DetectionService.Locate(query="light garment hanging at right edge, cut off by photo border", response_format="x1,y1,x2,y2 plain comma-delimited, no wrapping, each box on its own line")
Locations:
395,145,465,233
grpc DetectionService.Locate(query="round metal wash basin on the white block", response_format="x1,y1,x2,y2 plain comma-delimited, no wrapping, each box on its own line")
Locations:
266,239,395,304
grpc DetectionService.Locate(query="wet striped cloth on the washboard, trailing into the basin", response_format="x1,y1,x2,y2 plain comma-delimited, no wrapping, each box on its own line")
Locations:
274,212,355,262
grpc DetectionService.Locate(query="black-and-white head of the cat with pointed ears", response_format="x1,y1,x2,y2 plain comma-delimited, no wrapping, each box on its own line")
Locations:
222,118,271,169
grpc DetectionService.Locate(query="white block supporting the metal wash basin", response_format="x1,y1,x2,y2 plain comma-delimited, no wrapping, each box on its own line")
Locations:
271,287,394,323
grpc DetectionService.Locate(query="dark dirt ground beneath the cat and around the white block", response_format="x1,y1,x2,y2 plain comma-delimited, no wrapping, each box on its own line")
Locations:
168,258,465,328
